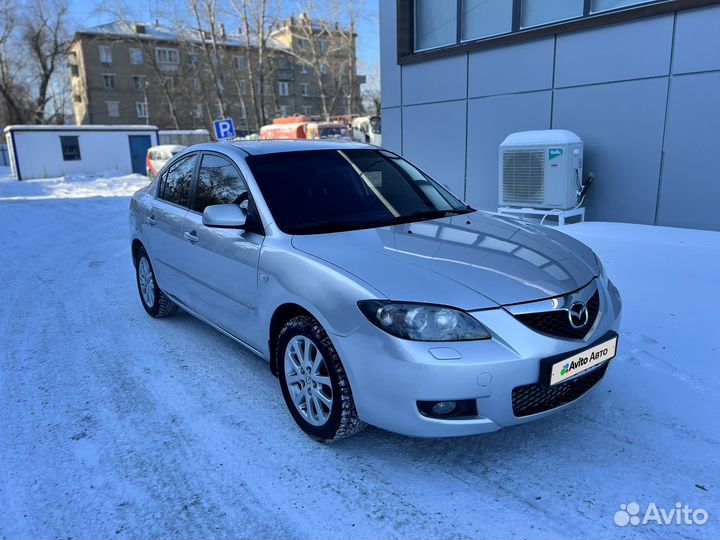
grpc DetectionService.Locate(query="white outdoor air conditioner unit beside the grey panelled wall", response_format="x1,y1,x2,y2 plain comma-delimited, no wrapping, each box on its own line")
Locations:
498,129,584,210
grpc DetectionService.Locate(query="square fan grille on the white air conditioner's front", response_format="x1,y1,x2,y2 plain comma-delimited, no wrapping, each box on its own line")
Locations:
502,150,545,204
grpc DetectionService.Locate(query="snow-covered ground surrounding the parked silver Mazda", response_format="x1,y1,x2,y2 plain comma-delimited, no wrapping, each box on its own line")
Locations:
0,176,720,539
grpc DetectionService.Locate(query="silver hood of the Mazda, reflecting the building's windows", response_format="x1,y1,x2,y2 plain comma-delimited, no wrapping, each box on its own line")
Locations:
292,212,598,309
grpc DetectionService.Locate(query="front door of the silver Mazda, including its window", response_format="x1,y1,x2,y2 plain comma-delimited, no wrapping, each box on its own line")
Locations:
182,152,265,347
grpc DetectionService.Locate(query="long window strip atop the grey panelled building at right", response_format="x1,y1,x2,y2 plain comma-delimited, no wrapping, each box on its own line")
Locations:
414,0,667,52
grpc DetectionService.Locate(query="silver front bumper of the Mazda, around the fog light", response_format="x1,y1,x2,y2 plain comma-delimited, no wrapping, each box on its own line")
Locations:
331,280,621,437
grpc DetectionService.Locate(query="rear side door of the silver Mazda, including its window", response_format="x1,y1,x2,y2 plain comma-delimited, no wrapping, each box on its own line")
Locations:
144,154,198,301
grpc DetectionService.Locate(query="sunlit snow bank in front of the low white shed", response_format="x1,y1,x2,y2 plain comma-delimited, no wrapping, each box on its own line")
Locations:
0,167,148,201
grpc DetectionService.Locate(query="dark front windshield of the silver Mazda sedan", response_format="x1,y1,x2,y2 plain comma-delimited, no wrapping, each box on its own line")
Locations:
247,149,473,234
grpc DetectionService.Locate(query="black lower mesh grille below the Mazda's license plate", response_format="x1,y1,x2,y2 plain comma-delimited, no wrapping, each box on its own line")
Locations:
512,362,609,416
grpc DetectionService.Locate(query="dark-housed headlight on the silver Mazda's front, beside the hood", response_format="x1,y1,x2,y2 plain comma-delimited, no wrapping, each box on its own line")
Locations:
358,300,490,341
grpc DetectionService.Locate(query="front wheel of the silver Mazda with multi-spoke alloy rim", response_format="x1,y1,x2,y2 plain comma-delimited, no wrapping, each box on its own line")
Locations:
276,315,365,442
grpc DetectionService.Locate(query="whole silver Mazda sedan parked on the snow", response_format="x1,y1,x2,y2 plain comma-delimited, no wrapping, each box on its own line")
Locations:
130,141,621,442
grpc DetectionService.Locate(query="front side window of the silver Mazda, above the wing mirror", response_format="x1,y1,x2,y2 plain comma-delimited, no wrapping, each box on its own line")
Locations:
193,154,248,212
